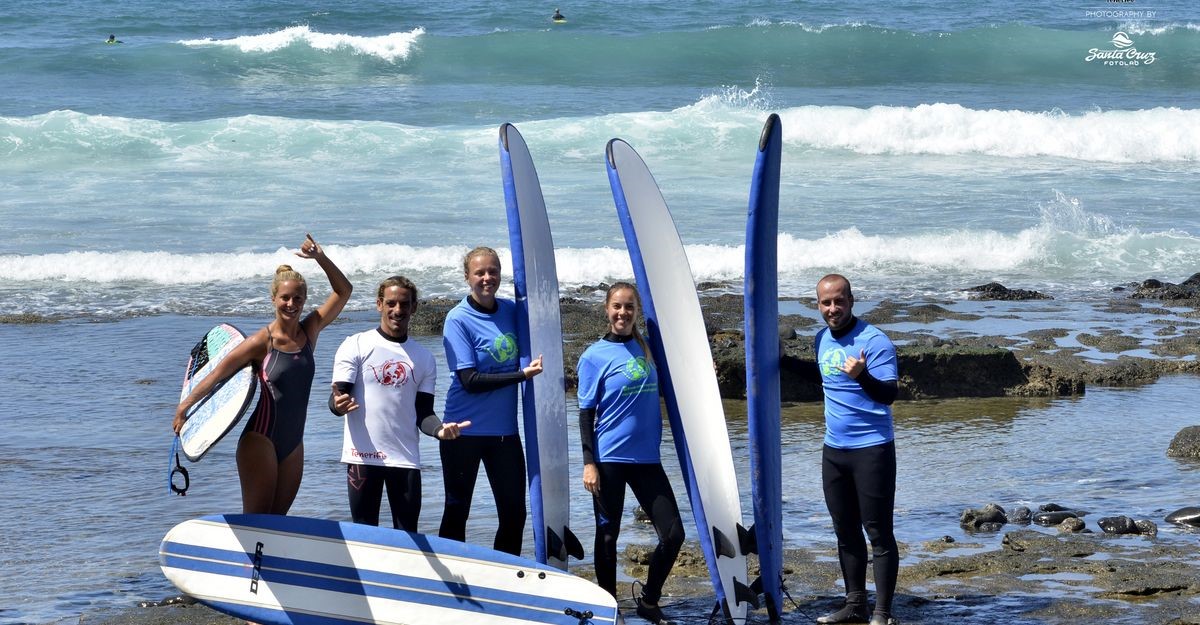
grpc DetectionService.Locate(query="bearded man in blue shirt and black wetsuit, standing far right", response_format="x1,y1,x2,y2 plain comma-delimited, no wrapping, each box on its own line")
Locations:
780,274,900,625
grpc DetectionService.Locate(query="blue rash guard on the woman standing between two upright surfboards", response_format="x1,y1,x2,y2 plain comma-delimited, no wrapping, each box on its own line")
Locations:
577,339,662,463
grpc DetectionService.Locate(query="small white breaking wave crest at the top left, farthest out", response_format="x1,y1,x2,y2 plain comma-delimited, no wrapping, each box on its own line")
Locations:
179,25,425,62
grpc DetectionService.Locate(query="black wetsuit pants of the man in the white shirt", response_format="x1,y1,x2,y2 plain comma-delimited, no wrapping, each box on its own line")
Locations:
346,464,421,531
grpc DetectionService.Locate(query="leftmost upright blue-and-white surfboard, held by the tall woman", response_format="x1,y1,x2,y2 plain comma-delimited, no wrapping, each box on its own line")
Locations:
500,124,583,570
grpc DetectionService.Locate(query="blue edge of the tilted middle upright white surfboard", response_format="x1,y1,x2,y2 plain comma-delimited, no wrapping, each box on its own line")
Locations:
605,139,730,606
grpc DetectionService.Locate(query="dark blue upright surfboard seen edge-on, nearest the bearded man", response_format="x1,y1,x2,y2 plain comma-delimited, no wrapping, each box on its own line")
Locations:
743,114,784,623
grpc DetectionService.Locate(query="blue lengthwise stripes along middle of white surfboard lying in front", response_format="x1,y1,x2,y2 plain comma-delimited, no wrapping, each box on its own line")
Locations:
161,542,611,620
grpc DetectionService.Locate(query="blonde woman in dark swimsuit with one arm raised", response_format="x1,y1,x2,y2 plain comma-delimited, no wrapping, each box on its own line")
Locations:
173,235,353,515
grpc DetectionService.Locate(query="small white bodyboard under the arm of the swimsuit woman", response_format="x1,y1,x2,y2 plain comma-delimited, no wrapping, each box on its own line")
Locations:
179,324,258,462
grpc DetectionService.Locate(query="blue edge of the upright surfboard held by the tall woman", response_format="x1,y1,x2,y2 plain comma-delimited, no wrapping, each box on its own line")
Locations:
499,124,547,564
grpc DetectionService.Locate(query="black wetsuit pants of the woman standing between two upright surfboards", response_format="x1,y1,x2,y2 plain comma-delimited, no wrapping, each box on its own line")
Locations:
592,462,684,603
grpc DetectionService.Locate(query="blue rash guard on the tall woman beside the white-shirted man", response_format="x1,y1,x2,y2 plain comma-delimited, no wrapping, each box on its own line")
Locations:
442,298,521,437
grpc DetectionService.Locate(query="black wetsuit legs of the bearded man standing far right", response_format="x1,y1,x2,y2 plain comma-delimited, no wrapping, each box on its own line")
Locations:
821,441,900,614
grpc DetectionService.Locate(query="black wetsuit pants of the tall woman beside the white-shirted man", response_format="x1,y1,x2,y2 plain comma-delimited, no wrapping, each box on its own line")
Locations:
438,434,527,555
